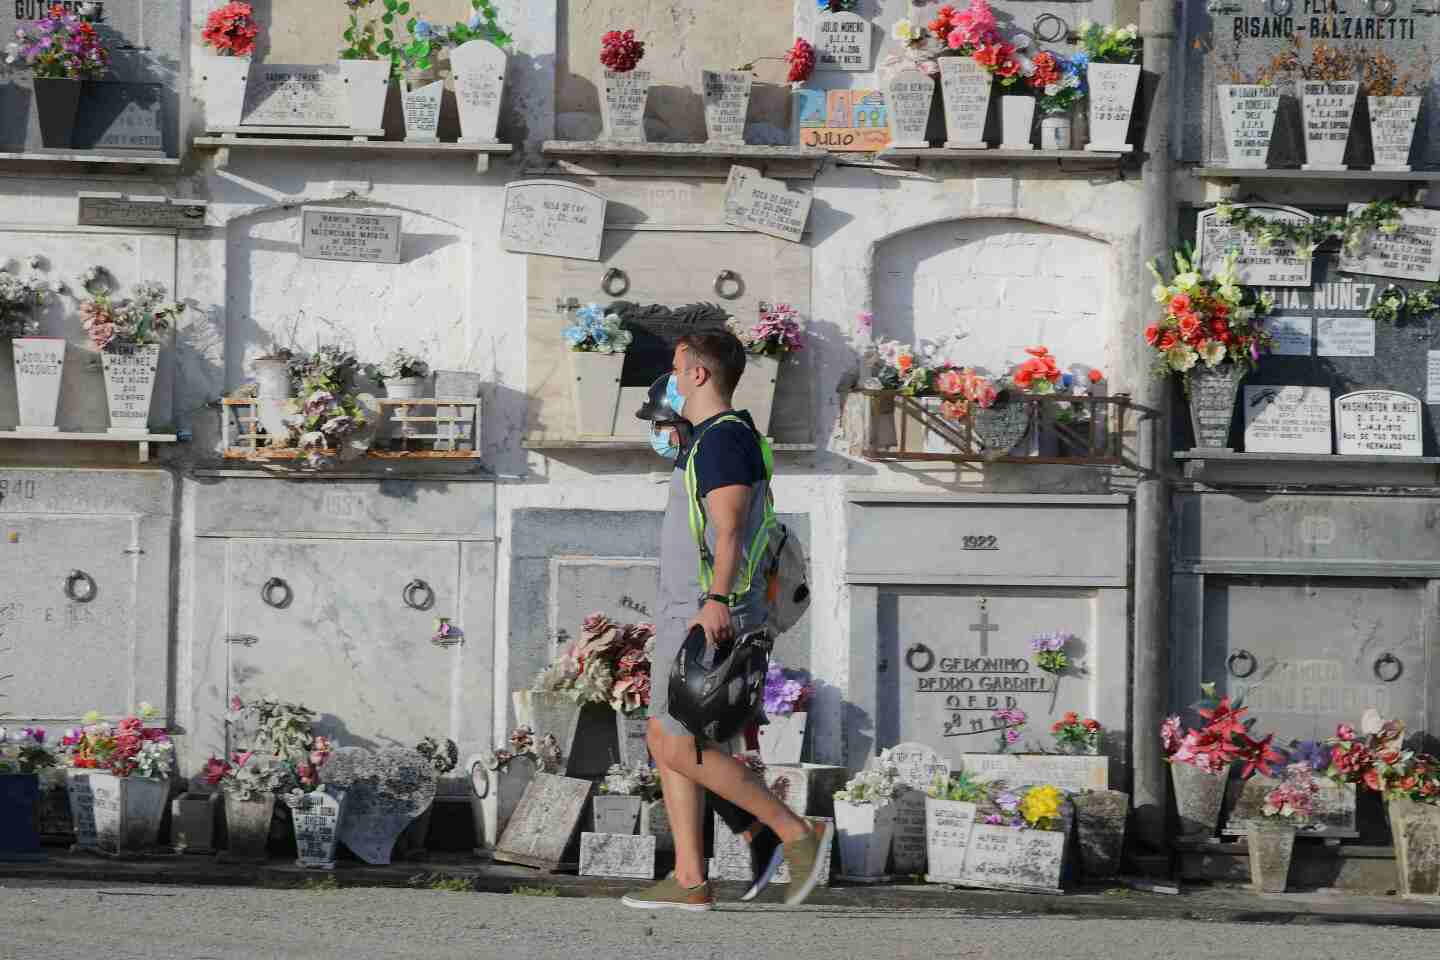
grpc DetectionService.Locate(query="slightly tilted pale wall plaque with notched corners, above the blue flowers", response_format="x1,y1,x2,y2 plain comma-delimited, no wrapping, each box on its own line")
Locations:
500,180,605,261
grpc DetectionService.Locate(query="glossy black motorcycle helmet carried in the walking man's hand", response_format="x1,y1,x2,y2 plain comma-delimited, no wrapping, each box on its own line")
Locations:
670,625,772,763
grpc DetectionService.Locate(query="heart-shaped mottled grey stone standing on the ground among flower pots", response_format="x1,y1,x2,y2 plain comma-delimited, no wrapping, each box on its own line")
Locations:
321,747,436,864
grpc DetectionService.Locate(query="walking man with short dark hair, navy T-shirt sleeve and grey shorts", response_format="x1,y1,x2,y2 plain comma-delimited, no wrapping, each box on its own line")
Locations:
624,331,829,911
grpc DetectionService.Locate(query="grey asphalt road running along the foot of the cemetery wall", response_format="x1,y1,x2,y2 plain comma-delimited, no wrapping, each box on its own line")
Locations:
0,881,1436,960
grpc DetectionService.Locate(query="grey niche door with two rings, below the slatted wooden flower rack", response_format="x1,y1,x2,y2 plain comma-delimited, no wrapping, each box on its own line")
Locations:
226,538,460,748
